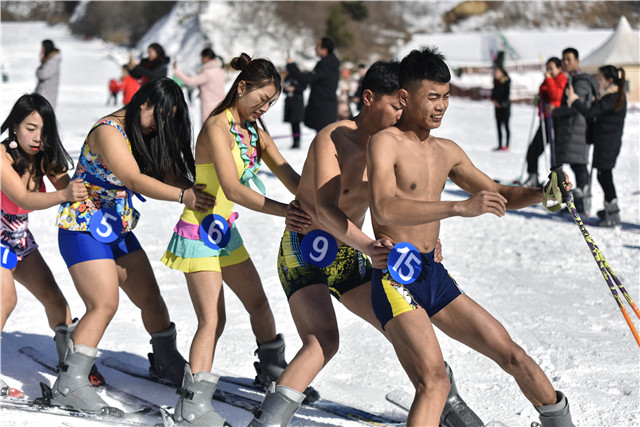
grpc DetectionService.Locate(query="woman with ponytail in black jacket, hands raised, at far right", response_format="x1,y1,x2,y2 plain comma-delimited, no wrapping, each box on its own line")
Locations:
567,65,627,227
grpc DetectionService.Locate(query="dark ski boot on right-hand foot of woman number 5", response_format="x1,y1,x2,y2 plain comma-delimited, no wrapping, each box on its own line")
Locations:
148,322,187,387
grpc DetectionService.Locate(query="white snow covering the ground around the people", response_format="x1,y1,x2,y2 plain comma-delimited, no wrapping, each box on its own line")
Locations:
0,23,640,426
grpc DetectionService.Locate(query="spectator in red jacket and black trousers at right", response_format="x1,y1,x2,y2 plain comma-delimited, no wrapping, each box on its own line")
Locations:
523,57,567,187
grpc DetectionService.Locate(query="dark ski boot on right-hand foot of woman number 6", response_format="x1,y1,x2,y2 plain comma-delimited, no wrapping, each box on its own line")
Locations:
253,334,320,402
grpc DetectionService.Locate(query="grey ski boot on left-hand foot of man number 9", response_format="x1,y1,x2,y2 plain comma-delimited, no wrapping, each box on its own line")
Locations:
248,382,305,427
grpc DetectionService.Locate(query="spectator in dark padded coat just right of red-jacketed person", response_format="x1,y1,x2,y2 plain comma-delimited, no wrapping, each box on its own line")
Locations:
553,47,598,215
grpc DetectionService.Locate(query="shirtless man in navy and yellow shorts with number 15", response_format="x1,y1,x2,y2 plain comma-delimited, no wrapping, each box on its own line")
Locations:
367,49,573,427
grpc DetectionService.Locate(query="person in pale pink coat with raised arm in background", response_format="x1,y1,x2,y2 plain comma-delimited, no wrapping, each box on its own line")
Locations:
173,47,225,123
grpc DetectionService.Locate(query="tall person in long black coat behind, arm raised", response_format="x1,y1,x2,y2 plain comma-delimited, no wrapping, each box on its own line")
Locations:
287,37,340,132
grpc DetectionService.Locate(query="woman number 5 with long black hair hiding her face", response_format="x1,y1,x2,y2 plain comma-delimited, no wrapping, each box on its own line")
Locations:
51,77,214,413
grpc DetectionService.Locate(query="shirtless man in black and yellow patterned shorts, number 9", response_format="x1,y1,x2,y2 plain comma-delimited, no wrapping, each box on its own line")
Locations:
249,62,483,427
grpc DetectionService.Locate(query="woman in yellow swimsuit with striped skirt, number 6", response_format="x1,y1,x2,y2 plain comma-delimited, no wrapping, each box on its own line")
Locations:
162,53,310,425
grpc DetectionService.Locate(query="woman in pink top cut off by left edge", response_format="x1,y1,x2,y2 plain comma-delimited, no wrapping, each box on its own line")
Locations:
0,93,90,397
